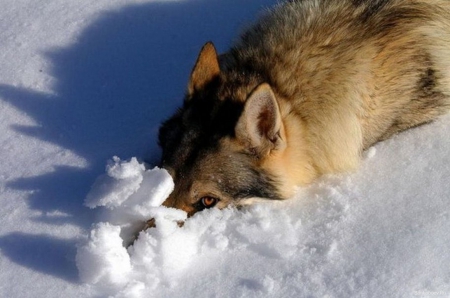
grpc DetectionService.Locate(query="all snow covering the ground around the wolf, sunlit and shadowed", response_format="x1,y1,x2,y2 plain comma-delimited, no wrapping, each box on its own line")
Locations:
0,0,450,298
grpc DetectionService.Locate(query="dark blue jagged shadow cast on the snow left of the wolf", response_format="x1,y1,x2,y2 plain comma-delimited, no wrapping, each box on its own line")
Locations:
0,0,276,281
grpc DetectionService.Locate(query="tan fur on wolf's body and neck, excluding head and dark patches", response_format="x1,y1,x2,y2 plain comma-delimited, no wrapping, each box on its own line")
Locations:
225,0,450,189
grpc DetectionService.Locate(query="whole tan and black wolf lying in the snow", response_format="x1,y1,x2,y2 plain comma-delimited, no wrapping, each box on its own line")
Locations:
160,0,450,215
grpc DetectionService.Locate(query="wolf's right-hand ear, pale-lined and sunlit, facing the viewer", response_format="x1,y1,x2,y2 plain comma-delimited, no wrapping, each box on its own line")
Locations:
236,83,283,157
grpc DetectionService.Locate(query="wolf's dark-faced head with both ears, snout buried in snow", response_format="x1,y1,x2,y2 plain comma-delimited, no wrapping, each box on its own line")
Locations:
159,43,314,215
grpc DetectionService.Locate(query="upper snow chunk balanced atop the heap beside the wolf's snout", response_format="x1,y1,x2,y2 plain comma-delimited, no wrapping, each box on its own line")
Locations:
85,156,178,243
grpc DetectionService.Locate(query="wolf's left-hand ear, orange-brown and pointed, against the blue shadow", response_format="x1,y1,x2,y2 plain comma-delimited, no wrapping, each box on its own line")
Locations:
188,42,220,95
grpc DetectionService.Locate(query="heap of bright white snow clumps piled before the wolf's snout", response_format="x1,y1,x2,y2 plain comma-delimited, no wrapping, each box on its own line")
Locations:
76,157,182,297
